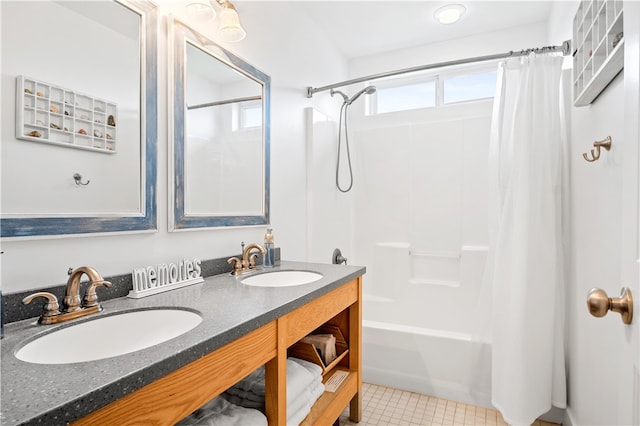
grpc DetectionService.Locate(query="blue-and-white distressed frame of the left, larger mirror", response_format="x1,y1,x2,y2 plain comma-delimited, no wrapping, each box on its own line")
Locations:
0,0,158,238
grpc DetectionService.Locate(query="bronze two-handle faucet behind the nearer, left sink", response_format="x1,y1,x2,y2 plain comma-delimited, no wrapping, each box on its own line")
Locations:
22,266,111,324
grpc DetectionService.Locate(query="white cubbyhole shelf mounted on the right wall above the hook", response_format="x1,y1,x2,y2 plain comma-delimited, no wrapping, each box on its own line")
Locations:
573,0,624,106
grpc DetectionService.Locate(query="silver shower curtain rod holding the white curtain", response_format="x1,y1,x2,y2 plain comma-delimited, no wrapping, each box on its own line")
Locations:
307,40,571,98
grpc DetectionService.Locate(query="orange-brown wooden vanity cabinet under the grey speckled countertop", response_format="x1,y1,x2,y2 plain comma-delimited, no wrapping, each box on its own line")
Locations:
74,277,362,425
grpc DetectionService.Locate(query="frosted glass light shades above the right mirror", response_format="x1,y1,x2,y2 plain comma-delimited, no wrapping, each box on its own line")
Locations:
186,0,247,42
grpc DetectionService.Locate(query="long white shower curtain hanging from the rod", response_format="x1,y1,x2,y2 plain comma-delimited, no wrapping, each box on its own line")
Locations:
485,54,568,425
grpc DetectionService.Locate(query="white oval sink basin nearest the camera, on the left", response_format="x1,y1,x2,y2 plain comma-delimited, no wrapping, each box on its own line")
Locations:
15,308,202,364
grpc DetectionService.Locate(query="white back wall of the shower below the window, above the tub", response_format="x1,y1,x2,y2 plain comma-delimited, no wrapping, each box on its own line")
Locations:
353,100,493,333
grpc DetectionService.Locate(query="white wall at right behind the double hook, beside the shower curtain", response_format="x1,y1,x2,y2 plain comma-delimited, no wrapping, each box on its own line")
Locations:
549,1,637,425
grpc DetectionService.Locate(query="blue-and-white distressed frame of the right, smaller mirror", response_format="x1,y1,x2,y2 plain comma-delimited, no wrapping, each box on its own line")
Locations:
169,18,271,231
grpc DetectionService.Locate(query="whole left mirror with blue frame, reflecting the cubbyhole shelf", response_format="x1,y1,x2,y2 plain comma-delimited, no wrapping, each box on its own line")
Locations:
0,0,158,238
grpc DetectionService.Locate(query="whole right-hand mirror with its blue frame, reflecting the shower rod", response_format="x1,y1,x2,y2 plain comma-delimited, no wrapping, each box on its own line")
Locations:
169,19,270,231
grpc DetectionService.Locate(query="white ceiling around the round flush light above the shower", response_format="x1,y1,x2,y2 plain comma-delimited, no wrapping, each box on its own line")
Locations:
291,0,558,59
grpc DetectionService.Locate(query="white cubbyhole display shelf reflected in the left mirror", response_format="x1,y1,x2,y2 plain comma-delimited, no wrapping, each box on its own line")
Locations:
16,76,118,154
